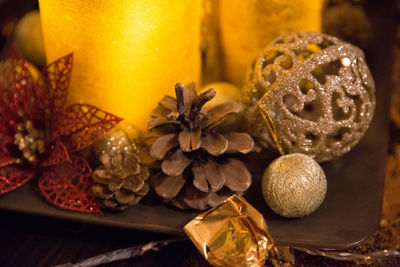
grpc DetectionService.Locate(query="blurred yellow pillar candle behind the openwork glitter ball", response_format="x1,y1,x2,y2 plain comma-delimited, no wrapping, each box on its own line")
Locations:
219,0,323,86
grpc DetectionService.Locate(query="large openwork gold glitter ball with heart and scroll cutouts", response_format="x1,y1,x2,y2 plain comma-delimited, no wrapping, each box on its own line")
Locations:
244,32,375,162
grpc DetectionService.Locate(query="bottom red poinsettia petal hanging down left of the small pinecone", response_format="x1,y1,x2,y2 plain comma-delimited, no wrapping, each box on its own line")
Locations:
39,157,100,213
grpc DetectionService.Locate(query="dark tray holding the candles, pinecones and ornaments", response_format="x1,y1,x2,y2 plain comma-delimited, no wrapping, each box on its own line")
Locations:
0,1,394,249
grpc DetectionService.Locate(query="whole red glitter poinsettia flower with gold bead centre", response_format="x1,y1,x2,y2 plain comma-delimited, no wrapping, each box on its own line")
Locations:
0,54,121,213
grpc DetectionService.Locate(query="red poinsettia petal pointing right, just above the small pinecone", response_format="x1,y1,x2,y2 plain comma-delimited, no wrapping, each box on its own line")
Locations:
59,104,122,151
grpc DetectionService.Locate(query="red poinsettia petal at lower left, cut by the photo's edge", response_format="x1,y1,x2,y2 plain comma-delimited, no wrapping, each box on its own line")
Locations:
0,166,33,194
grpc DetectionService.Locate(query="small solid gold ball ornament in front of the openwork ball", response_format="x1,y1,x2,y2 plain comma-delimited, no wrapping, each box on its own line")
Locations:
262,153,327,218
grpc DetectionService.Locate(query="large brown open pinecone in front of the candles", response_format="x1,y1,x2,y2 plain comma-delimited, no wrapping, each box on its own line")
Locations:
149,83,254,210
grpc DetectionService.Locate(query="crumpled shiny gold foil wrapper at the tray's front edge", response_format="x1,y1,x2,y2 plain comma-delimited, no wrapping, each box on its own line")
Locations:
184,195,274,267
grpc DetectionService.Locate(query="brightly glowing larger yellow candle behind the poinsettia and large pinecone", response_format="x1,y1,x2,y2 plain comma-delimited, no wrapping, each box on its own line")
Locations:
39,0,202,129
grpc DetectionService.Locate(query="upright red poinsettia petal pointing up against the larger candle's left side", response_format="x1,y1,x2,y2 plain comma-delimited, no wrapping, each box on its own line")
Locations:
36,54,73,113
